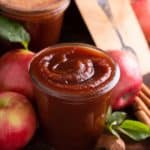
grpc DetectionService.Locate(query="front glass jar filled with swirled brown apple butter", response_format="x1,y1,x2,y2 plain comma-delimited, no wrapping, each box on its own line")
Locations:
29,43,120,150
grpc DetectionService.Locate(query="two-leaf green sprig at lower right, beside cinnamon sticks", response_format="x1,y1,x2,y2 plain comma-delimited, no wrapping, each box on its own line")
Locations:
106,109,150,141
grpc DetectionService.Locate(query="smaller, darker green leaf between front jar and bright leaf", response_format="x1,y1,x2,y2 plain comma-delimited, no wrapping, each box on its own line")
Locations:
106,111,127,125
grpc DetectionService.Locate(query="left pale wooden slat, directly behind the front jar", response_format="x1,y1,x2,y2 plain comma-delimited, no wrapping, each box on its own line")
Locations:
75,0,121,50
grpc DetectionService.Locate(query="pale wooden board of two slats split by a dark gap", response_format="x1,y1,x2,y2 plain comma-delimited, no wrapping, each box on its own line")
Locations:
75,0,150,75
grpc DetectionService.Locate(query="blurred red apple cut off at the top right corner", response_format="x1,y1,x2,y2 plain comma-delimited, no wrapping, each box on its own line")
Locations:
131,0,150,42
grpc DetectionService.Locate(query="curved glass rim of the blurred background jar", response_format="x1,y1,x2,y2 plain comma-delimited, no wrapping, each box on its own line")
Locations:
0,0,71,16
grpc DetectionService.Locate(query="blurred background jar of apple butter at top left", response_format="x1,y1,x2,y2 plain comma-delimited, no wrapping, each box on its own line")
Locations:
0,0,70,51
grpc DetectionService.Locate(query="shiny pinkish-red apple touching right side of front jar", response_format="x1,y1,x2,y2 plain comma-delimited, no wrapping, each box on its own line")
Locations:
108,50,142,109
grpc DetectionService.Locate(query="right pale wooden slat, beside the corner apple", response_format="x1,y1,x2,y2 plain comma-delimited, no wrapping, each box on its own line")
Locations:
110,0,150,74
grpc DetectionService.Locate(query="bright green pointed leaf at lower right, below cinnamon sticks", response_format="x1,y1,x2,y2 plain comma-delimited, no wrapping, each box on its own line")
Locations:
117,120,150,141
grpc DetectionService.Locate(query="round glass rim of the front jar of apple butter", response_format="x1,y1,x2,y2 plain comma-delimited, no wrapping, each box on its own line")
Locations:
29,43,120,103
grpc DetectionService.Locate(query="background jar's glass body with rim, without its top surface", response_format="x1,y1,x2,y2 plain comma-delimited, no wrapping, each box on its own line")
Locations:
0,0,70,51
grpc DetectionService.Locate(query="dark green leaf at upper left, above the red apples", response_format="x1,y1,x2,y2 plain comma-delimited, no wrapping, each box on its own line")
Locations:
0,16,30,49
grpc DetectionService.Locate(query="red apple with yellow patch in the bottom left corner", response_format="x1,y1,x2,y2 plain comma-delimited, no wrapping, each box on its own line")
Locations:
0,92,36,150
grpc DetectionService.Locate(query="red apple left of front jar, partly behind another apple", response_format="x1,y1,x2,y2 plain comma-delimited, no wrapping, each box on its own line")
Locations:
0,50,34,99
